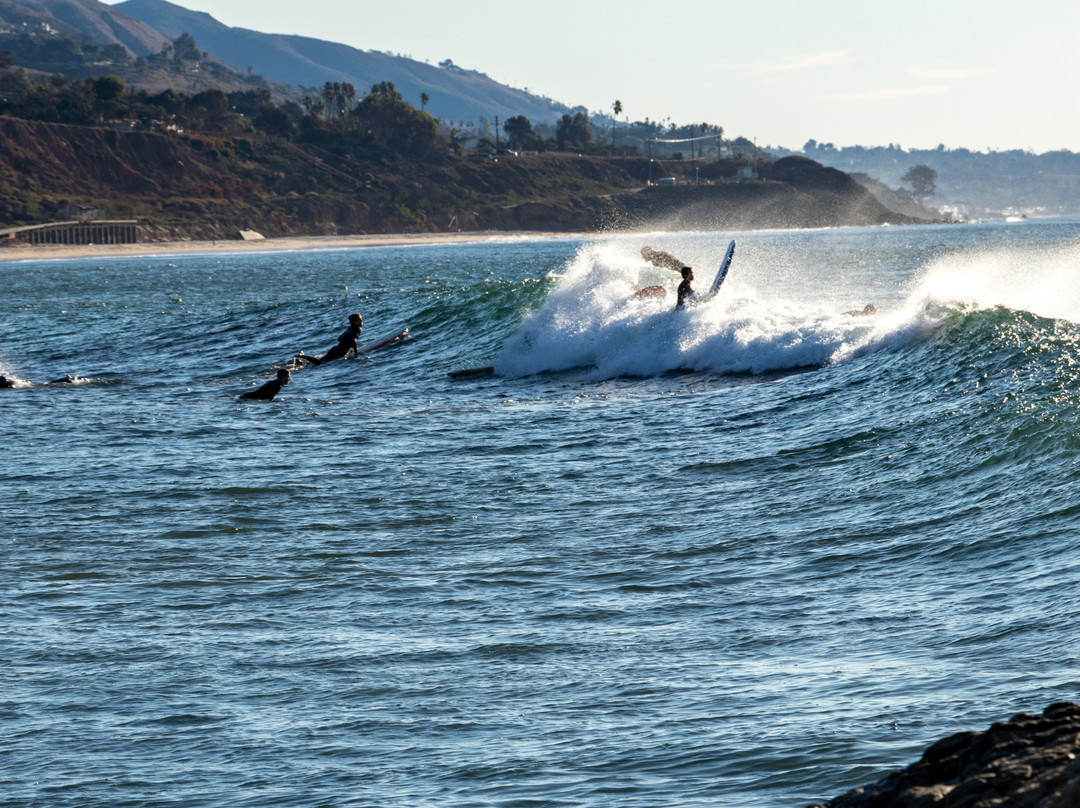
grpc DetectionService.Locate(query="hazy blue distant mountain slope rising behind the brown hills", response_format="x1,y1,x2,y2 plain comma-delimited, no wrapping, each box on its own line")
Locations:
112,0,570,122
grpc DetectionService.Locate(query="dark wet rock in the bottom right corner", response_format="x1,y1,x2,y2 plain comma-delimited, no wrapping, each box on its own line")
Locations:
811,701,1080,808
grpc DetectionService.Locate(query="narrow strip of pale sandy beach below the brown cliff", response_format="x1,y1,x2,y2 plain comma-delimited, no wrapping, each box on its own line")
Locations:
0,230,583,261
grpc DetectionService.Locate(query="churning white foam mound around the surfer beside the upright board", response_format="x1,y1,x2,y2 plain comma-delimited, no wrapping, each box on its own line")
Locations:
496,241,896,378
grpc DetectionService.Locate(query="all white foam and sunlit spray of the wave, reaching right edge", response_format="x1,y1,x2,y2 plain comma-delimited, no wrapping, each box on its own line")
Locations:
496,234,1080,378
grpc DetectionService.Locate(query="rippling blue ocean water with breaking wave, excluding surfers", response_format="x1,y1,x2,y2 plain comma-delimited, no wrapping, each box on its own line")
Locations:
0,220,1080,808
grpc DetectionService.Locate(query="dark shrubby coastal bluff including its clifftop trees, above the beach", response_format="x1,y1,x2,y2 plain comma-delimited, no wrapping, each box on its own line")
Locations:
0,61,937,239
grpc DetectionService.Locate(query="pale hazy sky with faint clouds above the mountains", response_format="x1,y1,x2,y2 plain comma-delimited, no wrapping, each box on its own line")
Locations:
103,0,1080,152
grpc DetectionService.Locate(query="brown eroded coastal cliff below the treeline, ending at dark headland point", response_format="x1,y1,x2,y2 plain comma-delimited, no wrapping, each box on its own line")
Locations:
0,117,933,239
